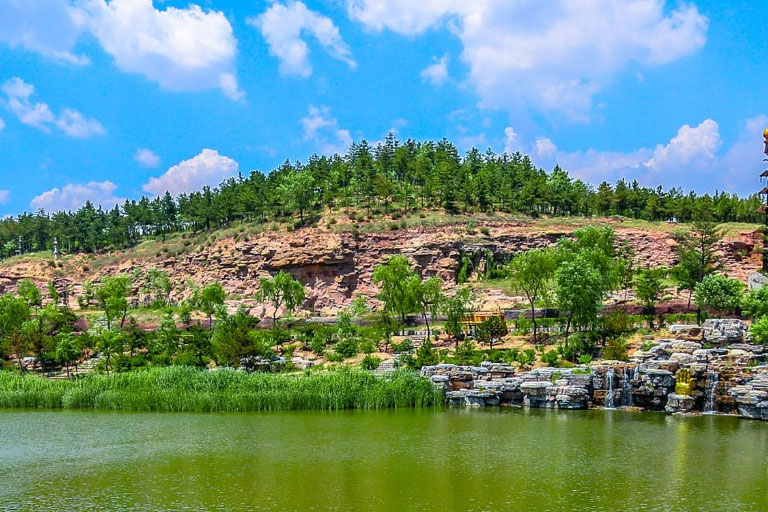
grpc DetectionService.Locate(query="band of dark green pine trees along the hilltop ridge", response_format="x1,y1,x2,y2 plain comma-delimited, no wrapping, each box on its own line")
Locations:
0,135,760,256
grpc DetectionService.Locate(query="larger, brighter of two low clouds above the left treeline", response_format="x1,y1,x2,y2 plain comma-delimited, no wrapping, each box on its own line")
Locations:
142,149,238,196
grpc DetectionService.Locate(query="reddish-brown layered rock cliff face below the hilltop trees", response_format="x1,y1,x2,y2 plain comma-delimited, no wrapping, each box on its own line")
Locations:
0,222,760,314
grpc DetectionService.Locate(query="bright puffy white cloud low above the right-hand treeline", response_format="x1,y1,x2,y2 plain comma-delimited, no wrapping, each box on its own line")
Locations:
645,119,723,172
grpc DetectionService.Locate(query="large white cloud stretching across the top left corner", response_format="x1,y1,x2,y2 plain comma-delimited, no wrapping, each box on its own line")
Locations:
0,0,243,100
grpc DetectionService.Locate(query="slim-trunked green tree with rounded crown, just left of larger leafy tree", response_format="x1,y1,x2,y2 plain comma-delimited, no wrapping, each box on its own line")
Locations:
509,249,556,344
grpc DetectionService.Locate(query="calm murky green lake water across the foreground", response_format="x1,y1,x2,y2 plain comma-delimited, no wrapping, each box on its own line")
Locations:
0,409,768,512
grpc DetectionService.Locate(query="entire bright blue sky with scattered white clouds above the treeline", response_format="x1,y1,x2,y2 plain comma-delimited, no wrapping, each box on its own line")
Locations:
0,0,768,214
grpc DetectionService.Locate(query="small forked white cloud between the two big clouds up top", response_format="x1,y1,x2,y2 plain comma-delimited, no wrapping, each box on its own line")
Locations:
255,1,357,77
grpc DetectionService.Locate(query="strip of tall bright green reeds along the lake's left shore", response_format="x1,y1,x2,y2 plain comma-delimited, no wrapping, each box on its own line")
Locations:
0,367,442,412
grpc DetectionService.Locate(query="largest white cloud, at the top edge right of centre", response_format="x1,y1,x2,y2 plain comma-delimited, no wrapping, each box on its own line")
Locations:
347,0,708,121
